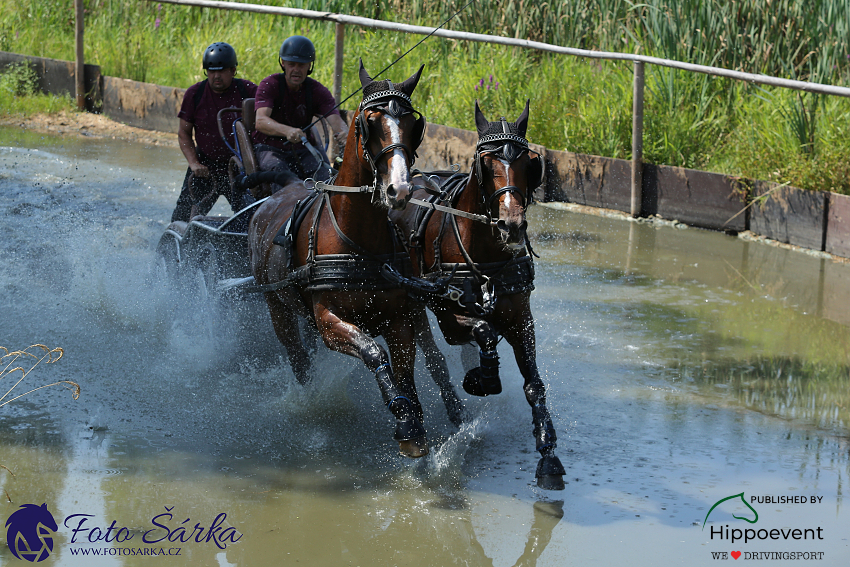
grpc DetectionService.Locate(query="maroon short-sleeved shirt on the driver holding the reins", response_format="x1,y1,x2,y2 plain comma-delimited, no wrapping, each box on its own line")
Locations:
253,73,339,150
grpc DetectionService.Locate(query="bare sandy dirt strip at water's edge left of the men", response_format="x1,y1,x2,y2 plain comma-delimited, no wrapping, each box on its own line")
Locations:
0,112,177,147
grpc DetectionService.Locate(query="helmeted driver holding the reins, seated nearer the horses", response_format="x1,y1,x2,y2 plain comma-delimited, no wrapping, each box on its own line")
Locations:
253,35,348,187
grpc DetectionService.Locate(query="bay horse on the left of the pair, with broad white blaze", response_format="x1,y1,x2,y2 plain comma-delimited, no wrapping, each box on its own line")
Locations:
248,60,428,458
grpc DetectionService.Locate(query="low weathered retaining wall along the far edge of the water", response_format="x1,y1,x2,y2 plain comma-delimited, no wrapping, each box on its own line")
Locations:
6,52,850,258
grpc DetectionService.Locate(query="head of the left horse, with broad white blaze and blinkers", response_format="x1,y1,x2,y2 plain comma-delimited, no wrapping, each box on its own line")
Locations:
354,60,425,210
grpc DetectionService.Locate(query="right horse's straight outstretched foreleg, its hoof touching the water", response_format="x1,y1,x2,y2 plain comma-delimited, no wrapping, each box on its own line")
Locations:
506,311,567,490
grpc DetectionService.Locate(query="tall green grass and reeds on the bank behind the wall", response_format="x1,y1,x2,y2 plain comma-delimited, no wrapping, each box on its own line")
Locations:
0,0,850,194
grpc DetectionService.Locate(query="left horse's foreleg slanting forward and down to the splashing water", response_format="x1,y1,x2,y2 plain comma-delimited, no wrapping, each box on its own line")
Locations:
315,303,428,458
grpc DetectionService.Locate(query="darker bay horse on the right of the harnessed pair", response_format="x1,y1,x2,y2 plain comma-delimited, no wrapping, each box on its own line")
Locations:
390,101,566,490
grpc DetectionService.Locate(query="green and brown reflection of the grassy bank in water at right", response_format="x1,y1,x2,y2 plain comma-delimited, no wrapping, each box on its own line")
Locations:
538,205,850,440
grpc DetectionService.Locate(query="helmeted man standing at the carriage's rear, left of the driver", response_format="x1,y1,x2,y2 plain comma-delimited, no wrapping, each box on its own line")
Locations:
171,42,257,222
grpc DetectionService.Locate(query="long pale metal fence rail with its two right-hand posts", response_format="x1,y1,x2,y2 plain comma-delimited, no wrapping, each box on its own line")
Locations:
148,0,850,216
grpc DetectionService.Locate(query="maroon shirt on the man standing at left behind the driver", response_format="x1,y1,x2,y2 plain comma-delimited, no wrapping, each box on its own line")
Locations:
177,79,257,166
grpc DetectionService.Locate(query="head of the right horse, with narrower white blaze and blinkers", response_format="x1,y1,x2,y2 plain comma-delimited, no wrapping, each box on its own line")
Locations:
474,101,543,252
